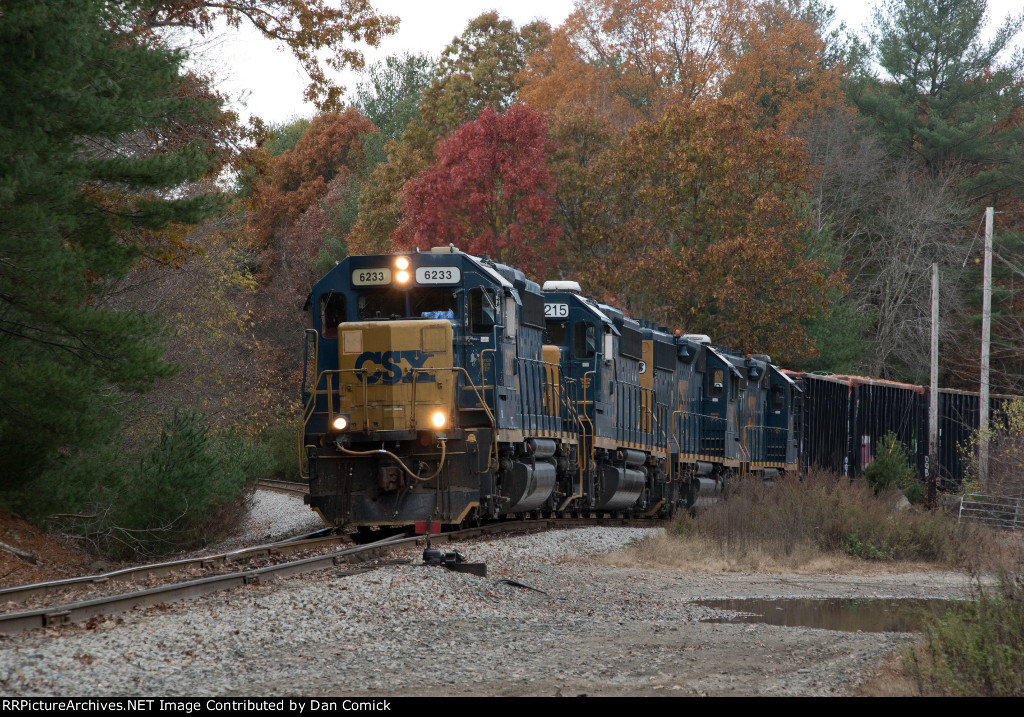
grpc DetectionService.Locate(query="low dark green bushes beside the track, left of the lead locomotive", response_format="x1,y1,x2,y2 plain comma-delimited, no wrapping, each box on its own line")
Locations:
9,411,268,558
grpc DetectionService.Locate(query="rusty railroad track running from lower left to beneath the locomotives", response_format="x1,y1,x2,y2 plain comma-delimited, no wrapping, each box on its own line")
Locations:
0,518,652,634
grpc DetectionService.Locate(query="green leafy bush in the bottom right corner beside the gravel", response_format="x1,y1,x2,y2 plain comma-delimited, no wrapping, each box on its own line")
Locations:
903,566,1024,697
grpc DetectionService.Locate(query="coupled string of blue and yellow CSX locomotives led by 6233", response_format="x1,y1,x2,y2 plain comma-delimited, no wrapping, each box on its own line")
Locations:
300,247,798,526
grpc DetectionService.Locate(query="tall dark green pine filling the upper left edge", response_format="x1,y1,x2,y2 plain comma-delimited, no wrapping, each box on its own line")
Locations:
0,0,219,490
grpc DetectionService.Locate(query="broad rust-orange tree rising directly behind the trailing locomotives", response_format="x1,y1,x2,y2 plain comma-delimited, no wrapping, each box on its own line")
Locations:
589,100,841,361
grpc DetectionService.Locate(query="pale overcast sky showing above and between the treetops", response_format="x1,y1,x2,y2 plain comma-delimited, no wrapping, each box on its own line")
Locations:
197,0,1020,123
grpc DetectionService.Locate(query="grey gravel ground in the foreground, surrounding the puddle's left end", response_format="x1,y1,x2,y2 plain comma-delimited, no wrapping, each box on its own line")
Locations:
0,496,966,697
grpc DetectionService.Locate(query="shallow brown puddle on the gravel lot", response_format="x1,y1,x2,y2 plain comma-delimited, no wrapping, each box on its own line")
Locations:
696,597,953,632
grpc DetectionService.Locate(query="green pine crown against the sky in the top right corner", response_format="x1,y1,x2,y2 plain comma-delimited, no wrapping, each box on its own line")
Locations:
854,0,1024,197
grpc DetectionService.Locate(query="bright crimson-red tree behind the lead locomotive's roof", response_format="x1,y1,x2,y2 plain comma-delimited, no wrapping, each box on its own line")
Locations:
394,104,559,278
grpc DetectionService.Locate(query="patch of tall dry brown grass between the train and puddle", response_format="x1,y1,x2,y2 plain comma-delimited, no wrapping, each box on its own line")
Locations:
603,473,1020,574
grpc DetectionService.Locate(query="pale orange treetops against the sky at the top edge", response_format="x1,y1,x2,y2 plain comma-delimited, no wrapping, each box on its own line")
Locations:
519,0,841,129
